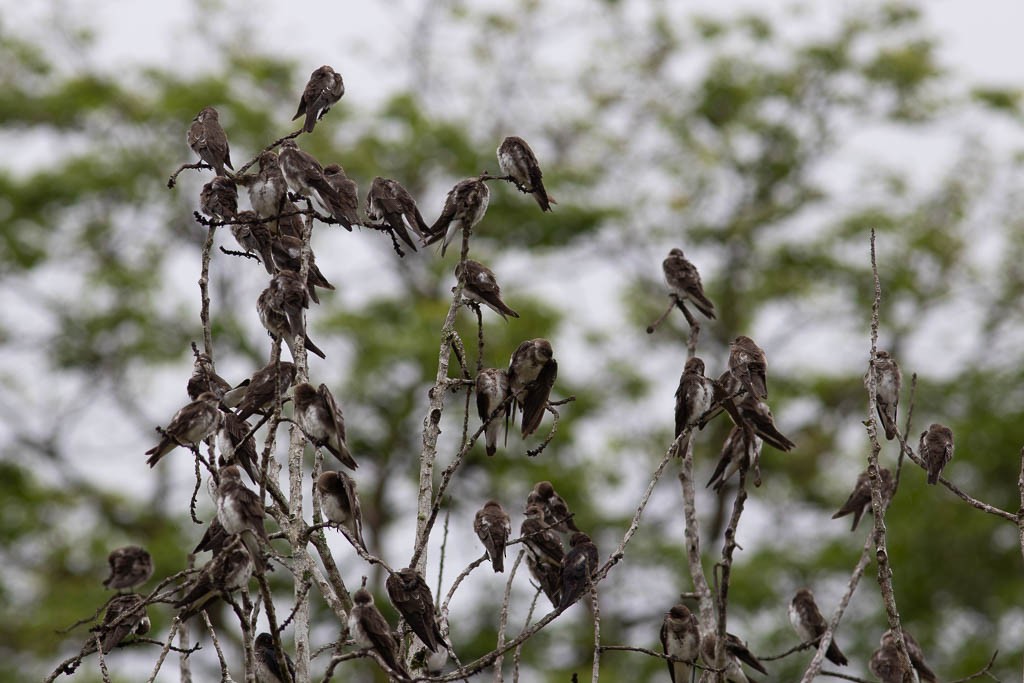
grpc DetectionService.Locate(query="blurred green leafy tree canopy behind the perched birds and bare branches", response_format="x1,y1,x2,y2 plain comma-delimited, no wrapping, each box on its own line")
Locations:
0,0,1024,681
